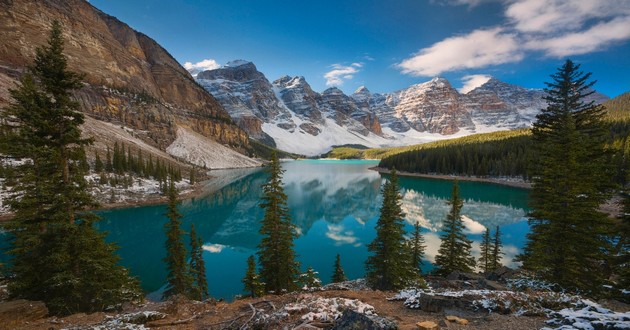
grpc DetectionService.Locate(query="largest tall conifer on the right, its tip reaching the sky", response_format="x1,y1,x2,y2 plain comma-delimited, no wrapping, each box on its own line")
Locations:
519,60,613,291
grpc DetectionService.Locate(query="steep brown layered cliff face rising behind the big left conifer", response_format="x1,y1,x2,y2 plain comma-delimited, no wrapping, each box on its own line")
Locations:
0,0,248,157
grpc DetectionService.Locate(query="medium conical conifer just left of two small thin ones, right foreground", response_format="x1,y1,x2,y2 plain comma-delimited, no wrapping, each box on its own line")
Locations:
435,180,475,276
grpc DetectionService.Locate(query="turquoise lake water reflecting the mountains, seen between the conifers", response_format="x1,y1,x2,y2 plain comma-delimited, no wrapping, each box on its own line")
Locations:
97,160,529,300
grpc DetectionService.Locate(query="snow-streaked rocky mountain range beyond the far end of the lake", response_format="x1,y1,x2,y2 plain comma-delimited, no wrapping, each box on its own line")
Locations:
196,60,607,155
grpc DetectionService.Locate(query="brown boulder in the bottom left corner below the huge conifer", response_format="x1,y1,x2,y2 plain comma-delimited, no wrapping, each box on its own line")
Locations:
0,299,48,329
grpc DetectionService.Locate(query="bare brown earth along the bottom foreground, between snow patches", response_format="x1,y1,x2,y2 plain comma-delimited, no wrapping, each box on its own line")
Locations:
3,290,544,330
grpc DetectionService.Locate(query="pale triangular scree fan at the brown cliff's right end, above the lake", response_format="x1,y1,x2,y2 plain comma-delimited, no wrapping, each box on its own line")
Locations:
166,126,262,169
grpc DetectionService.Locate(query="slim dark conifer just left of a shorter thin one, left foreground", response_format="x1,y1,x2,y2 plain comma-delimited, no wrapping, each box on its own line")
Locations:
162,180,195,299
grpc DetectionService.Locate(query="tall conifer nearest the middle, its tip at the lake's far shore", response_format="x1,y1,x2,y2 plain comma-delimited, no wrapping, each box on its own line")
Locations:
258,152,299,294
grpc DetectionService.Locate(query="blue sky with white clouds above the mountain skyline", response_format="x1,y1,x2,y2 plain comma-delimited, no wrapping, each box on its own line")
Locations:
90,0,630,97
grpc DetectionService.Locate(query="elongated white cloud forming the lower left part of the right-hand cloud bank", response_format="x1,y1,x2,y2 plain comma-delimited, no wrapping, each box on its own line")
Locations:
397,28,523,76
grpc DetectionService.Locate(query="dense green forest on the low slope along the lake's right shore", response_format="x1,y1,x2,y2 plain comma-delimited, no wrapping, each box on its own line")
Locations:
378,93,630,184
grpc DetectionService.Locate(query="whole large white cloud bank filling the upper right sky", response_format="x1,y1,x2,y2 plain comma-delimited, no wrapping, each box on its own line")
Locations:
397,0,630,76
